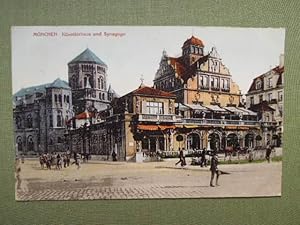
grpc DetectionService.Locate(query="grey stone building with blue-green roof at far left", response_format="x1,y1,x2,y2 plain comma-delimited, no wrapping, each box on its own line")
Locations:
13,78,73,154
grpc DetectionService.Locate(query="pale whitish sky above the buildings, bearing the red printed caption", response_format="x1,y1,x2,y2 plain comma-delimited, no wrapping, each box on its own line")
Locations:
11,26,285,95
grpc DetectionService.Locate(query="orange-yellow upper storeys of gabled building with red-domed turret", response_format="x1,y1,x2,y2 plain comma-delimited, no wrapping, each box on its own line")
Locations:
154,36,241,106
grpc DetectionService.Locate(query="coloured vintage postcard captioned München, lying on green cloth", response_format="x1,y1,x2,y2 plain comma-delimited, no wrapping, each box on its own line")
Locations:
11,26,285,201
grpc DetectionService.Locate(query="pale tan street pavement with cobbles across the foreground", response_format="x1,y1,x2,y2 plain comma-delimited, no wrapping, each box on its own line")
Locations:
16,159,282,201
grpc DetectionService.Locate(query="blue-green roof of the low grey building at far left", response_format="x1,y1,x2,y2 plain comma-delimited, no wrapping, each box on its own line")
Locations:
14,78,71,97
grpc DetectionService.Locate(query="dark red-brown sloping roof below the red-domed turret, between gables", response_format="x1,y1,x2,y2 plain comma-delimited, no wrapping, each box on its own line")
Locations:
169,54,209,82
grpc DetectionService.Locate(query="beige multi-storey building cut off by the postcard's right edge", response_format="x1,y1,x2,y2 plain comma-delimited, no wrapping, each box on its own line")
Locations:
246,55,284,146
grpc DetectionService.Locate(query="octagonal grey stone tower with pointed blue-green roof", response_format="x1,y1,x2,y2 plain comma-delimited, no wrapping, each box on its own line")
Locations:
68,48,110,114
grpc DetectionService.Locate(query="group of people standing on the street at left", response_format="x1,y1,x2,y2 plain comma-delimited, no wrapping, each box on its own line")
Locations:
39,152,88,170
